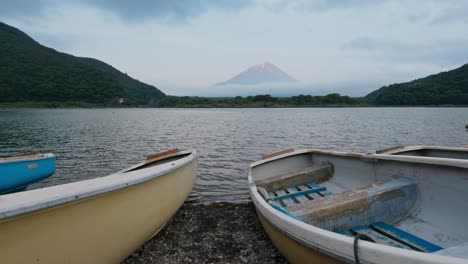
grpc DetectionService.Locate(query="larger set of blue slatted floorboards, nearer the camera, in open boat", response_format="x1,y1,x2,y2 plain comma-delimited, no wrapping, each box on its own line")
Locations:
335,222,443,253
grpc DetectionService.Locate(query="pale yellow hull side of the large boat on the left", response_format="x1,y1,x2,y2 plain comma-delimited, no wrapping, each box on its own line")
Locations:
0,160,197,263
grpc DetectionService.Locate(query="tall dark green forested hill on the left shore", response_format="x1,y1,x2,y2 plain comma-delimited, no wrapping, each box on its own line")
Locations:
0,22,165,105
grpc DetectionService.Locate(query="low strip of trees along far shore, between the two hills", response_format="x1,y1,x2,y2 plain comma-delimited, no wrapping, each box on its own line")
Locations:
158,93,365,107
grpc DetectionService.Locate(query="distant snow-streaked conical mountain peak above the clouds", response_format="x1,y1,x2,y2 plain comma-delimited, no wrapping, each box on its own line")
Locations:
217,62,297,85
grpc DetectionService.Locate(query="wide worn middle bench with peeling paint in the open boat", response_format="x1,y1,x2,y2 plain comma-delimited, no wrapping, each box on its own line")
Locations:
288,177,418,231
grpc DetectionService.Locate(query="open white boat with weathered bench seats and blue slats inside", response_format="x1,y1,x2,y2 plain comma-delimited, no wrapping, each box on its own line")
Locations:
248,147,468,263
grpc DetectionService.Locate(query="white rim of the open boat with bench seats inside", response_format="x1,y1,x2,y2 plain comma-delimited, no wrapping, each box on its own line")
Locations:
248,149,468,263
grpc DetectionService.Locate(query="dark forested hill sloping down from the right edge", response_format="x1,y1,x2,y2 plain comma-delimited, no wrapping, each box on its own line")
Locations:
366,64,468,105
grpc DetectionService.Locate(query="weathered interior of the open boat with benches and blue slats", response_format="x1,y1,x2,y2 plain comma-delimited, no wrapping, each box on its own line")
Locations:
250,151,468,258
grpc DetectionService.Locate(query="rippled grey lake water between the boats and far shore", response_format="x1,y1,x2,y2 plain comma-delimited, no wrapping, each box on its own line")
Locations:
0,108,468,202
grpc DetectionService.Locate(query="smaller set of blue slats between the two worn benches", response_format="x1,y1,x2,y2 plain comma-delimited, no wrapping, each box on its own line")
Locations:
268,183,332,207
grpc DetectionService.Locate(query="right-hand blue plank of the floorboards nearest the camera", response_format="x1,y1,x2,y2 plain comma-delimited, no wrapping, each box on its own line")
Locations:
370,222,443,252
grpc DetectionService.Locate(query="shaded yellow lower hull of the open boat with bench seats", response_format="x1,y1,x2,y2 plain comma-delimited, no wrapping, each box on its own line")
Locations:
257,211,343,264
